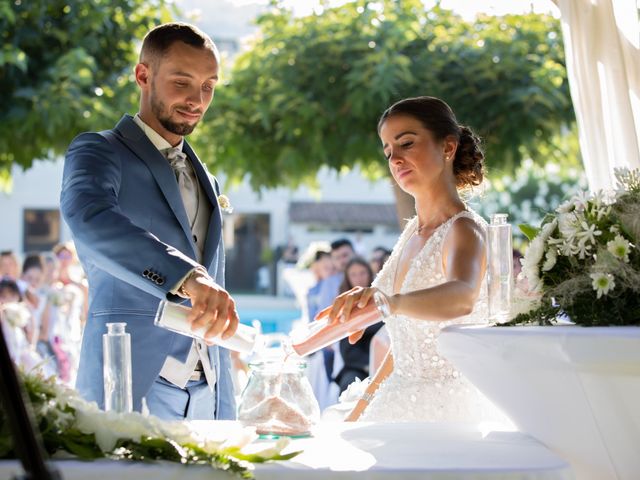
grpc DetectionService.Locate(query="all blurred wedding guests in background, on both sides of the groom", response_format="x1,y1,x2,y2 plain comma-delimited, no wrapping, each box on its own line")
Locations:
0,238,396,408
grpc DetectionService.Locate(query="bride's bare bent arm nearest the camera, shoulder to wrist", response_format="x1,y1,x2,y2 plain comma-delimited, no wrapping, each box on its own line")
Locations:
389,218,487,321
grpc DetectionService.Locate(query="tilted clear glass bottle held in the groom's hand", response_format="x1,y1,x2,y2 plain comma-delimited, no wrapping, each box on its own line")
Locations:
154,300,259,353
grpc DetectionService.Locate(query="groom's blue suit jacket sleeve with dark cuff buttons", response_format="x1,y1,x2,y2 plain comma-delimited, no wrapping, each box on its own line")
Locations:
60,133,198,300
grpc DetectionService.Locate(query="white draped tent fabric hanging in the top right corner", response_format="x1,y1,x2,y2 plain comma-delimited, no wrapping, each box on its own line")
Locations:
555,0,640,191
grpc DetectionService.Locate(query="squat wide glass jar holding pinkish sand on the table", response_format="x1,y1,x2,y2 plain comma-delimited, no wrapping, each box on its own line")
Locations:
238,358,320,437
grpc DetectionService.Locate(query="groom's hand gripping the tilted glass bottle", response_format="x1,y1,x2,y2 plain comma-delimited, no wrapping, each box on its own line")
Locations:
182,269,239,345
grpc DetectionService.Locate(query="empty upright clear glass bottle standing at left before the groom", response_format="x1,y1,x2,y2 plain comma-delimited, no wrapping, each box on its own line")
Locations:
102,323,133,413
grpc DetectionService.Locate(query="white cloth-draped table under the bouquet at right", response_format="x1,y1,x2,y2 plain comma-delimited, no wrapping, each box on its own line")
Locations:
439,326,640,480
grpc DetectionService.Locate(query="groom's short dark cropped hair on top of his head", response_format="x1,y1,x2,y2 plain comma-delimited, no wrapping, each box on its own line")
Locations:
140,22,219,63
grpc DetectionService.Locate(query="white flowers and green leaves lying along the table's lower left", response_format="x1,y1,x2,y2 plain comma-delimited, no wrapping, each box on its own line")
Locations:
0,373,300,478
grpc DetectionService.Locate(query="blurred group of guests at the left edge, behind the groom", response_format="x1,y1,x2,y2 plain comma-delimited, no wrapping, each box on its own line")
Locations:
0,244,87,385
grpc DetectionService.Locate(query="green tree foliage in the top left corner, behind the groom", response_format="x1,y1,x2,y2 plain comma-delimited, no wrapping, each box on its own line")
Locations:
0,0,170,178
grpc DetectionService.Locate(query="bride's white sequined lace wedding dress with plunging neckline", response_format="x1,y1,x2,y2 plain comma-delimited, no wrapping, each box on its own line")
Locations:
360,211,501,422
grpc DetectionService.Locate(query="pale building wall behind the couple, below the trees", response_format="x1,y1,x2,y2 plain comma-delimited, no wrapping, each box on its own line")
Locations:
0,159,397,262
